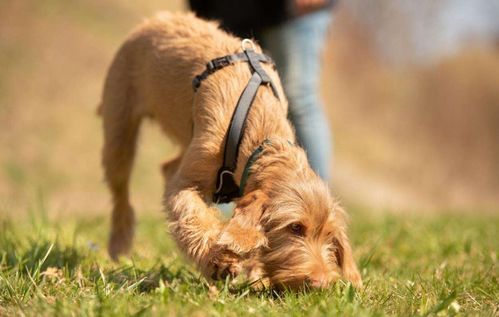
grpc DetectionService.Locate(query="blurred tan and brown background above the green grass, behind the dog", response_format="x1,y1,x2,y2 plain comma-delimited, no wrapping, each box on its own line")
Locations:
0,0,499,215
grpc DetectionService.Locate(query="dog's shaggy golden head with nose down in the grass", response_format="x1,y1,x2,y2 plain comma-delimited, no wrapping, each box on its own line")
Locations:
227,177,362,289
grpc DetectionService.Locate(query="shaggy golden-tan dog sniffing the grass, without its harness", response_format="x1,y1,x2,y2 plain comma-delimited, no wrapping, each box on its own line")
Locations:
99,12,362,289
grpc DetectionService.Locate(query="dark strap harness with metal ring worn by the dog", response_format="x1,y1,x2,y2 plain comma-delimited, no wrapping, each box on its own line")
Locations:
192,39,279,203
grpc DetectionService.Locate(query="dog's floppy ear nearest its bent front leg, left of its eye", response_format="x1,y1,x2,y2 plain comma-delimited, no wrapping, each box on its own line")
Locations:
218,190,268,255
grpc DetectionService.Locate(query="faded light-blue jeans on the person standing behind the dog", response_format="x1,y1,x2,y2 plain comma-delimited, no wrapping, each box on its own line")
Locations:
261,9,333,181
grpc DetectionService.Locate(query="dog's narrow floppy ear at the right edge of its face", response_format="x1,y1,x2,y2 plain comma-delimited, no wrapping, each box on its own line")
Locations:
333,230,362,287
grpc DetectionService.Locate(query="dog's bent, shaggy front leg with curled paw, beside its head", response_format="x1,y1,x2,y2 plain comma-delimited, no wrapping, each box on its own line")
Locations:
165,182,242,279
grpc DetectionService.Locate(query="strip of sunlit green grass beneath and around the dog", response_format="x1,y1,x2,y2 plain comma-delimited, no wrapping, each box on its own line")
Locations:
0,210,499,316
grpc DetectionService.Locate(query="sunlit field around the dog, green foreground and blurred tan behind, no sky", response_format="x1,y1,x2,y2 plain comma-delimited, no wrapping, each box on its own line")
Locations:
0,0,499,316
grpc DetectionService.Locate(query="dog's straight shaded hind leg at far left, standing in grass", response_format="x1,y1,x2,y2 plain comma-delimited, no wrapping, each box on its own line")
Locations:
98,46,141,260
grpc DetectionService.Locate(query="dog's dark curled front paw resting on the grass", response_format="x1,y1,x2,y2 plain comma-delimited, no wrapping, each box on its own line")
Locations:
209,248,243,280
